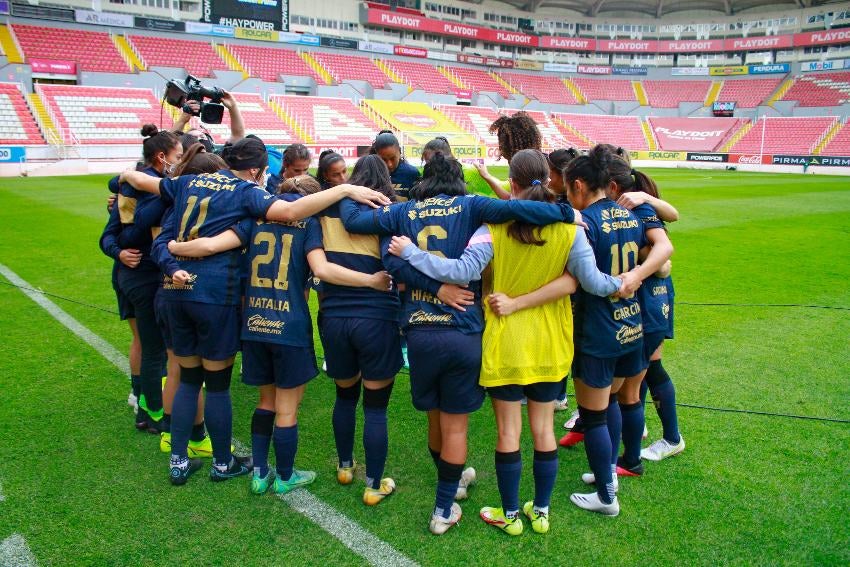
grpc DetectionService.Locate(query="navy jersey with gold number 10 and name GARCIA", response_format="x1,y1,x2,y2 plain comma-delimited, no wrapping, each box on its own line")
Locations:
575,198,646,358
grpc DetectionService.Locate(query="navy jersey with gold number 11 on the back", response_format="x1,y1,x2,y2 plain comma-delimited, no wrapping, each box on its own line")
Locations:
153,170,276,305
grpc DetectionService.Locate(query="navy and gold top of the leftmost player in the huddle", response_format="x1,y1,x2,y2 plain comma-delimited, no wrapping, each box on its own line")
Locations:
100,167,165,290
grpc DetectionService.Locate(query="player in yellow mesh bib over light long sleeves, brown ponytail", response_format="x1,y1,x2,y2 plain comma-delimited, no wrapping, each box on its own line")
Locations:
390,150,639,536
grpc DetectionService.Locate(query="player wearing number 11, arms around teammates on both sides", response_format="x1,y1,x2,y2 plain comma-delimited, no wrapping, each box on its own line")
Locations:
122,137,389,485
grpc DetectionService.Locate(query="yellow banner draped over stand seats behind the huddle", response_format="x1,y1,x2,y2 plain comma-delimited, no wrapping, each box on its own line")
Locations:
363,100,479,148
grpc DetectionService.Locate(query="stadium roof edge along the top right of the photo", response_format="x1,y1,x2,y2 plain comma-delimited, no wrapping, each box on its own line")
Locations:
480,0,839,18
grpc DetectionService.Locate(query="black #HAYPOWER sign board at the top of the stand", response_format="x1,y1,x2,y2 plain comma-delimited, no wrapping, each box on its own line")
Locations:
201,0,289,31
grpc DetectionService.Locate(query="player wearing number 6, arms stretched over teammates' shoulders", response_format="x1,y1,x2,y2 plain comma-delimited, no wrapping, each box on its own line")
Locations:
341,153,575,535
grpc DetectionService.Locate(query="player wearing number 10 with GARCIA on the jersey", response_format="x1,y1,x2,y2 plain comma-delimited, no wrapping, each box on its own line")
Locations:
564,147,672,516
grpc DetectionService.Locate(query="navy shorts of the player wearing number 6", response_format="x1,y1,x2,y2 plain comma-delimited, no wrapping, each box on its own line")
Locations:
407,327,484,414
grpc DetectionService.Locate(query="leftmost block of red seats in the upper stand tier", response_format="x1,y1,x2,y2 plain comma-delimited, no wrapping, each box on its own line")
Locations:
9,24,130,73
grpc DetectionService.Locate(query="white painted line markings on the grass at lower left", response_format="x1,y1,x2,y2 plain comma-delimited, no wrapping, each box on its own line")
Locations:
0,264,417,567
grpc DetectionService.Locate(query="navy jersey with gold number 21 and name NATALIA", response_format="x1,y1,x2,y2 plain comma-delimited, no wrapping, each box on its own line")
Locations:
234,213,322,347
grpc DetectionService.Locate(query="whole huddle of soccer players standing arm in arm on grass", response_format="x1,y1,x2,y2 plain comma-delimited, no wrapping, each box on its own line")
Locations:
101,113,684,535
